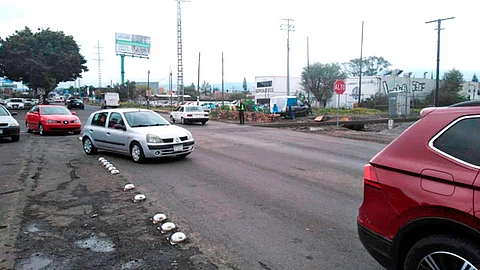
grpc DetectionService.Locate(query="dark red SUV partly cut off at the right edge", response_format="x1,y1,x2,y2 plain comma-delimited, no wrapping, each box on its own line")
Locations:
357,104,480,270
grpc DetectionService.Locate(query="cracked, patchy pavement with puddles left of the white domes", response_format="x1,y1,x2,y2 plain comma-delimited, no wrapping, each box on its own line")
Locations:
0,134,219,269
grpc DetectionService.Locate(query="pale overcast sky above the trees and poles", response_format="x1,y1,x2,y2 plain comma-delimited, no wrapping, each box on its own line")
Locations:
0,0,480,89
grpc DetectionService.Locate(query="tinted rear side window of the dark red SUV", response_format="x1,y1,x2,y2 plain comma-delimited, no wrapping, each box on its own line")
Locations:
433,117,480,166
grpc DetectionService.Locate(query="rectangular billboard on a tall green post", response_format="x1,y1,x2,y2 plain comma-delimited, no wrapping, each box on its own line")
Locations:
115,33,150,56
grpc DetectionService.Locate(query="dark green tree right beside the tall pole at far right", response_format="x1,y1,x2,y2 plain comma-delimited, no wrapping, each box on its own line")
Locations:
426,68,468,106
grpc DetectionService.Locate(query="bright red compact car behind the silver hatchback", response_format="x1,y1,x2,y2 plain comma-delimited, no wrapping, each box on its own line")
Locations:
25,105,82,135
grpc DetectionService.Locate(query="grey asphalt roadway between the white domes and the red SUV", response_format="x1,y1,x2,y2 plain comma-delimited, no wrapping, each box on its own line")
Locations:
0,106,384,269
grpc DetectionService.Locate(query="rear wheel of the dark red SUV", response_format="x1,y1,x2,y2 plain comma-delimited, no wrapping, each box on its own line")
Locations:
404,235,480,270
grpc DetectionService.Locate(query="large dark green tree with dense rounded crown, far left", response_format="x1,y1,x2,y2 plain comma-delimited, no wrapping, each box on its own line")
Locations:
0,27,88,97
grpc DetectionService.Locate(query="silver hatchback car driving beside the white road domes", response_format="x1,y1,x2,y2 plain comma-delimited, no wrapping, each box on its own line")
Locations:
82,109,195,163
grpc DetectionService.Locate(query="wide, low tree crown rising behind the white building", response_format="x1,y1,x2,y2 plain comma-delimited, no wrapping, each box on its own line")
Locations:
343,56,392,77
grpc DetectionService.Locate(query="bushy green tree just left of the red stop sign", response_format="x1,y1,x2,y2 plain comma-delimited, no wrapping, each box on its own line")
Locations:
301,63,347,107
